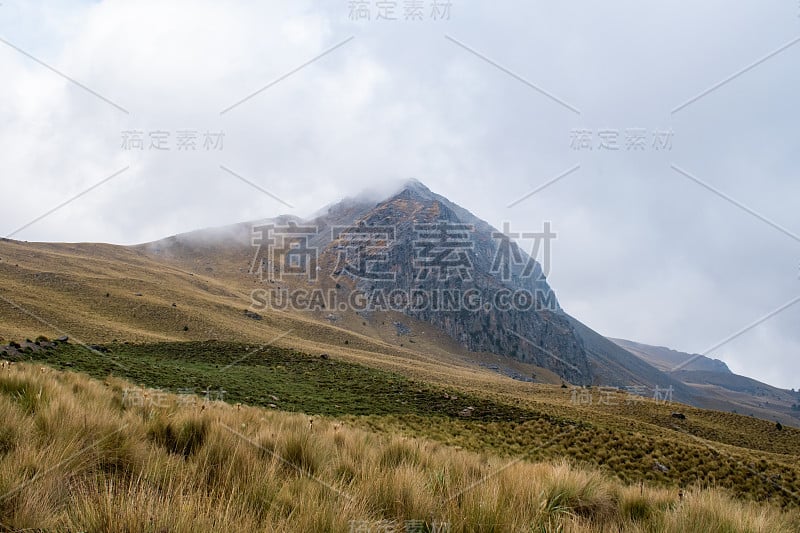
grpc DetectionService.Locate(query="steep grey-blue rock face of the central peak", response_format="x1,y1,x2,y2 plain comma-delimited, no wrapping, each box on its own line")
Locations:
320,182,592,385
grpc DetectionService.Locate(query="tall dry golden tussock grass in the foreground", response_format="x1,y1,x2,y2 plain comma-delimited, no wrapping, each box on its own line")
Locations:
0,365,800,532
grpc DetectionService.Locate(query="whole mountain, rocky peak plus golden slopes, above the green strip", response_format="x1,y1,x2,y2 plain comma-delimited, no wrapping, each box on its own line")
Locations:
0,181,800,421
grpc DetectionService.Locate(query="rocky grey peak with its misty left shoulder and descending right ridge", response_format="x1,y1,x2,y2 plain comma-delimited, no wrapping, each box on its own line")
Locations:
156,180,702,405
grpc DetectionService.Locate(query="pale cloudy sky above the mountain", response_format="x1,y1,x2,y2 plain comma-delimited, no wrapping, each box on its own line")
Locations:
0,0,800,388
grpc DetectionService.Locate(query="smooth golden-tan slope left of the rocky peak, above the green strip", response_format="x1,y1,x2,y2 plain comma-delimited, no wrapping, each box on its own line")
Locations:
0,239,536,389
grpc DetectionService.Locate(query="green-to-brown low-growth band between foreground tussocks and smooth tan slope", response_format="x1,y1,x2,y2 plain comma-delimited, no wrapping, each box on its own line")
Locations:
0,342,800,508
